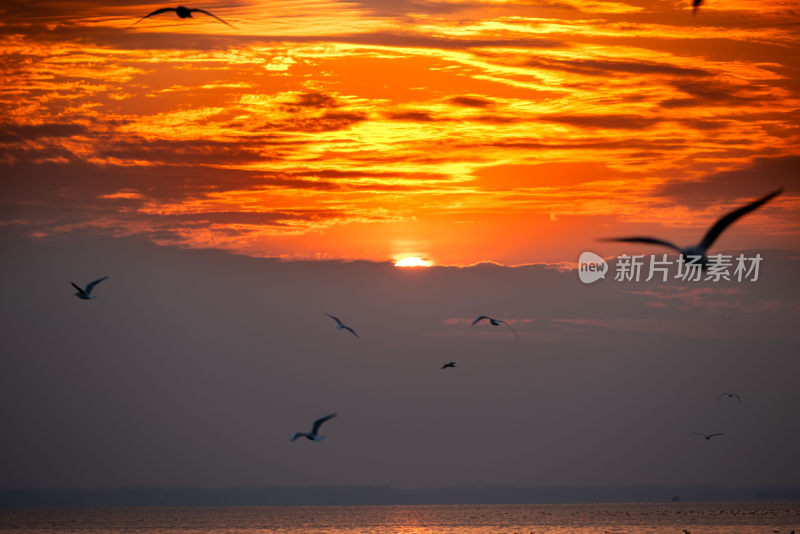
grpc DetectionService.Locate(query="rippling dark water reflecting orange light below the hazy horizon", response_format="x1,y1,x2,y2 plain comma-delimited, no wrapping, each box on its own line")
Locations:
0,503,800,534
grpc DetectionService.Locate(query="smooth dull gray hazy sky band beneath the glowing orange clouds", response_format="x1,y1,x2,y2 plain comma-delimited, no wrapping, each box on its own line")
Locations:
0,233,800,489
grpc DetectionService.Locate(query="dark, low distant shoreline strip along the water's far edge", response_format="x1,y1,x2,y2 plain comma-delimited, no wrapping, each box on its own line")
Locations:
0,485,800,508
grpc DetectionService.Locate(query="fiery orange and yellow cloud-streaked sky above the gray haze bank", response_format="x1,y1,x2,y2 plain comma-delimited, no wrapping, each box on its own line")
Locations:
0,0,800,264
